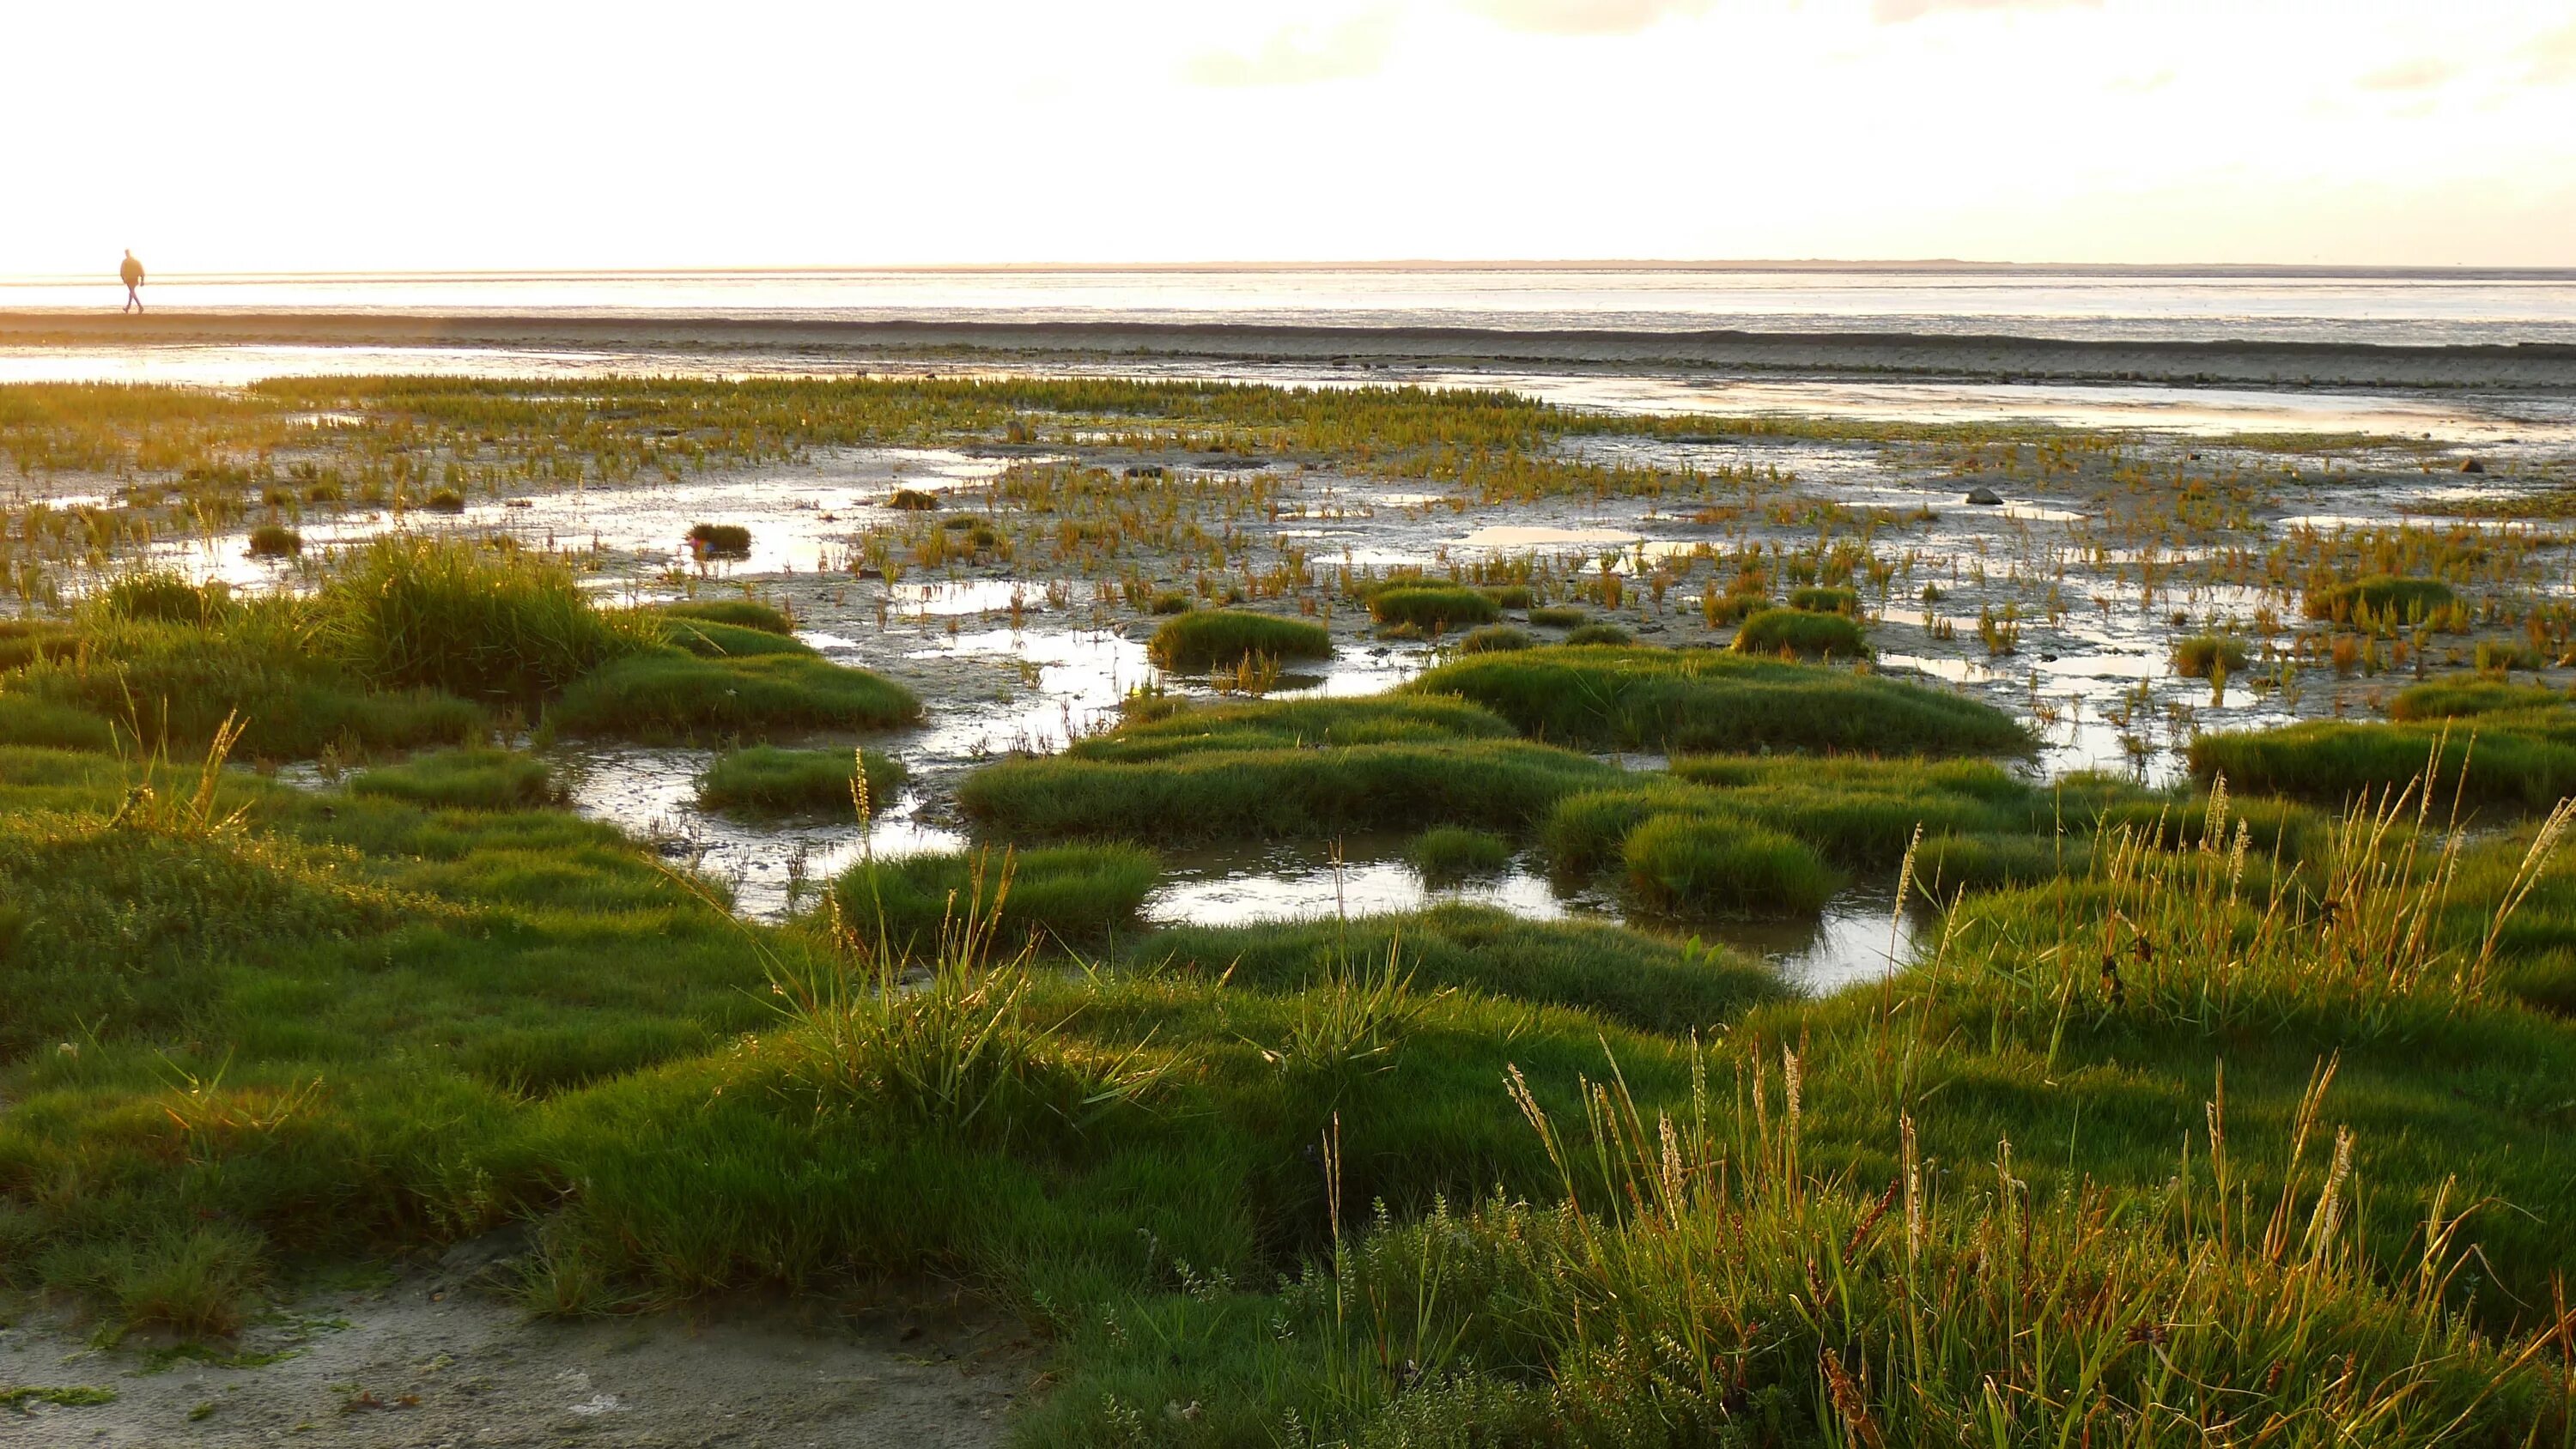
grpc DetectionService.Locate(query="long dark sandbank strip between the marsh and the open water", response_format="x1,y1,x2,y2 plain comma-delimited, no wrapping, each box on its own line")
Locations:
0,309,2576,391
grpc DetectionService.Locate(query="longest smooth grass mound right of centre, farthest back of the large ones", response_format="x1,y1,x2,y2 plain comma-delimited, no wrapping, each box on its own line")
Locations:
1409,648,2030,754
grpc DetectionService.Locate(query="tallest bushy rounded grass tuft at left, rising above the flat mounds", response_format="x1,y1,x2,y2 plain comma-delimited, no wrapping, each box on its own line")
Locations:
314,538,654,703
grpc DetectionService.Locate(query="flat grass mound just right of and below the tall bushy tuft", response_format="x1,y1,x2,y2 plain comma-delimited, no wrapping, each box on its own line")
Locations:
546,651,922,741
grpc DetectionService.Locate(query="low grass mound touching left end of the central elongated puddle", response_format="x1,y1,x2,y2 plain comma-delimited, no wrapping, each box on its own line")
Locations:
832,844,1162,955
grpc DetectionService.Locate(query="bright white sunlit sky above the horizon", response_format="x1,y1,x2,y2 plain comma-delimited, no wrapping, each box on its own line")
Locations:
0,0,2576,276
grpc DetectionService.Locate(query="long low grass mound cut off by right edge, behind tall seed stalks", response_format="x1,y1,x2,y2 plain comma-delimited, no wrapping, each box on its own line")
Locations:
2190,708,2576,810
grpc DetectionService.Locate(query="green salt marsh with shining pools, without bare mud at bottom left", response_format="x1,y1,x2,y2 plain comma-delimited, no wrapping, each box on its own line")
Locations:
0,371,2576,1444
